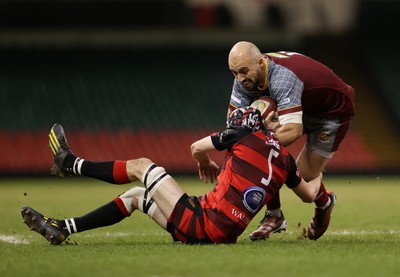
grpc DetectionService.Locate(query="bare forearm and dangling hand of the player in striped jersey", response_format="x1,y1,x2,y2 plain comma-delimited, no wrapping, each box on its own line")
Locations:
190,136,219,183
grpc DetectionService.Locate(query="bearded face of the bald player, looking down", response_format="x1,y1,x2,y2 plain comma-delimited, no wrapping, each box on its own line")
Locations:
229,58,260,91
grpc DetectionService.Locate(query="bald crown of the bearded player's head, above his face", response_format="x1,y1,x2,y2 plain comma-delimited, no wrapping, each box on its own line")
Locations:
228,41,263,67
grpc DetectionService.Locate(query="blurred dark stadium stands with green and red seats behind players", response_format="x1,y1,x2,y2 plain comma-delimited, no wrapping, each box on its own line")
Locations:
0,0,400,176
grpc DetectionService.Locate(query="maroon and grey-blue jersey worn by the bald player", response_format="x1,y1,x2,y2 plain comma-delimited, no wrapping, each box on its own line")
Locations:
230,51,355,118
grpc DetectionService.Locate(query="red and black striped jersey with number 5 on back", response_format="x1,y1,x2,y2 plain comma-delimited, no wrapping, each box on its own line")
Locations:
199,127,301,241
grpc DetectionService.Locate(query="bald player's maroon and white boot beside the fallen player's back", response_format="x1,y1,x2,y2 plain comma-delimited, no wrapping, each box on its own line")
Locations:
249,211,286,241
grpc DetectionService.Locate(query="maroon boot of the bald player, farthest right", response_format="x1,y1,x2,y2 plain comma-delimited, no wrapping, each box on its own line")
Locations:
307,192,336,240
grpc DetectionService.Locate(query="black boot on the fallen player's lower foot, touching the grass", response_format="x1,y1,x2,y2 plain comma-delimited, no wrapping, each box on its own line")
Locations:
21,206,69,245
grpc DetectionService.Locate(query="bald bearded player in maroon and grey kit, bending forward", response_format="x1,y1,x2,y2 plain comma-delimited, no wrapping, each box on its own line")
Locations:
228,41,355,240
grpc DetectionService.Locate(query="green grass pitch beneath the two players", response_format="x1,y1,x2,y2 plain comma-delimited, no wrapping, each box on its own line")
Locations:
0,176,400,277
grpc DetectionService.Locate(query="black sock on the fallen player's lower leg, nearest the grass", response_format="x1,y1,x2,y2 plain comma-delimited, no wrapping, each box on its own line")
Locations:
73,200,126,232
